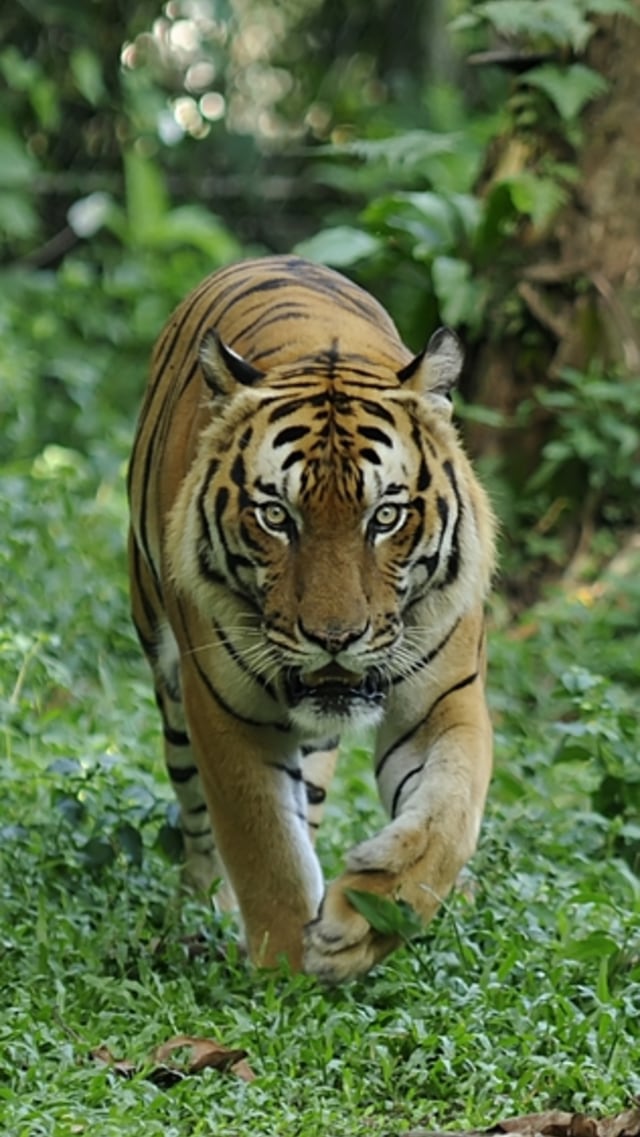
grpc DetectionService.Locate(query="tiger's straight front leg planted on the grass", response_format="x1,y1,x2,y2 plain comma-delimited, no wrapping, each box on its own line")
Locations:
183,659,326,970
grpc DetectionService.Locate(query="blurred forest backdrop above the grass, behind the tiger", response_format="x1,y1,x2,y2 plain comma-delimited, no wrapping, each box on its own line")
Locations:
0,0,640,607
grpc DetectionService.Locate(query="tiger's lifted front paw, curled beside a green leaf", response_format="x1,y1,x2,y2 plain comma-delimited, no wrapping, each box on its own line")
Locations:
304,873,400,984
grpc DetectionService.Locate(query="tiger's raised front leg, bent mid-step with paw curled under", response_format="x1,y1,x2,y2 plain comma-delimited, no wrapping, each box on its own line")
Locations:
305,683,491,982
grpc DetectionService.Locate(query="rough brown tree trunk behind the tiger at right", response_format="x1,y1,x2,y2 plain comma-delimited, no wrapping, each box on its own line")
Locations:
469,16,640,459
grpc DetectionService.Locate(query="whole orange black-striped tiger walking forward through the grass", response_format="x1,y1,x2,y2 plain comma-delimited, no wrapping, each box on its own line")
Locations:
128,256,496,984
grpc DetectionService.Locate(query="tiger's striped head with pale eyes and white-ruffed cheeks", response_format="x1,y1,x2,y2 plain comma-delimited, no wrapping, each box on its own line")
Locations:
168,329,492,737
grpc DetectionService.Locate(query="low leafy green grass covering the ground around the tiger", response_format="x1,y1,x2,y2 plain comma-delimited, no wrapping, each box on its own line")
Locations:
0,443,640,1137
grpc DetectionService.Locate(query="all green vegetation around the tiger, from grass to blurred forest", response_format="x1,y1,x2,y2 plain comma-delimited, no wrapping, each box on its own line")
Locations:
0,0,640,1137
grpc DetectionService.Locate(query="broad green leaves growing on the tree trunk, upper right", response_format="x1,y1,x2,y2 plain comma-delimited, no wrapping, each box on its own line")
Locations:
298,0,631,347
